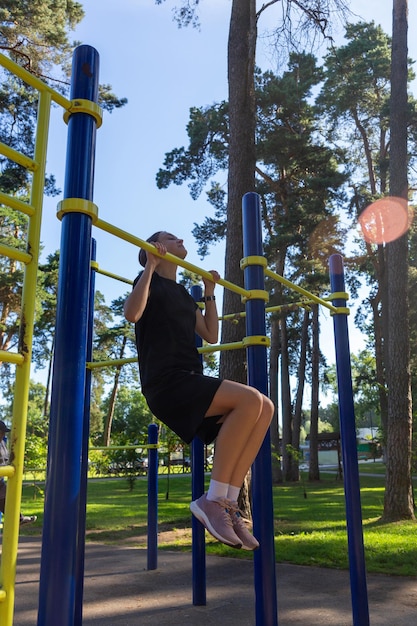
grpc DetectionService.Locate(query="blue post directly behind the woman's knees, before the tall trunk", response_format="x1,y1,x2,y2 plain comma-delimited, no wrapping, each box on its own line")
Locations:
242,192,278,626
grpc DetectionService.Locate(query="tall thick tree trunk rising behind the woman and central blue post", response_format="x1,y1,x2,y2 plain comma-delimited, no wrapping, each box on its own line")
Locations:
220,0,257,382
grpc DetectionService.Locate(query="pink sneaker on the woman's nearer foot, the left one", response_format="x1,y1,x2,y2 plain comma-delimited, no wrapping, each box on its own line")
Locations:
190,494,242,548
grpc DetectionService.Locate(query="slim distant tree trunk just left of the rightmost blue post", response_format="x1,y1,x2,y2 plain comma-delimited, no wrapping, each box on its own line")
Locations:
308,304,320,480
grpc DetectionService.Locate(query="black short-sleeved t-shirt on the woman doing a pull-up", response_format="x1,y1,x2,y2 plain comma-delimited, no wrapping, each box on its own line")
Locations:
134,272,202,389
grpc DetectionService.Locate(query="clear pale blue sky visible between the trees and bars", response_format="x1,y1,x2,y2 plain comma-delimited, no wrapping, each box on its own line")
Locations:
41,0,417,376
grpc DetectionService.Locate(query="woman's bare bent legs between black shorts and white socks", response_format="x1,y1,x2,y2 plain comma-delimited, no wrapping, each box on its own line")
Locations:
207,380,274,487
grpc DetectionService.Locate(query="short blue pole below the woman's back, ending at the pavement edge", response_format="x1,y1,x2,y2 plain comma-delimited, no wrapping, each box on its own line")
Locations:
147,424,158,570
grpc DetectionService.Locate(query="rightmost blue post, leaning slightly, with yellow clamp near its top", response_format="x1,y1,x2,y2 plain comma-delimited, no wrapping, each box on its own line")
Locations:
329,254,369,626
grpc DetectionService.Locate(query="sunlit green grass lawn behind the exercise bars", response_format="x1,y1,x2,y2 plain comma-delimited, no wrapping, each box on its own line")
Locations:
21,470,417,576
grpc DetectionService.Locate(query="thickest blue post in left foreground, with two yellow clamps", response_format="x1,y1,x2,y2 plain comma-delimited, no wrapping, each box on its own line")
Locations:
38,46,99,626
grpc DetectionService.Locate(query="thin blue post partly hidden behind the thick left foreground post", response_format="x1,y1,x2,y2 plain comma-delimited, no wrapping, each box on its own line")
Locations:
74,239,97,626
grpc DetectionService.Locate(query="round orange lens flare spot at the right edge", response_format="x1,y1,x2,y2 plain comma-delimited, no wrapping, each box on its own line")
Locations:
359,196,413,245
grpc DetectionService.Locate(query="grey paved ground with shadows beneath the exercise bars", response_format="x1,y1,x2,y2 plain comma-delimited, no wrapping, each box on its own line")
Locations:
14,537,417,626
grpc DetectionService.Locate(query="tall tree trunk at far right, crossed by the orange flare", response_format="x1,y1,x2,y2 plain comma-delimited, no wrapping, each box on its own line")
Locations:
383,0,414,520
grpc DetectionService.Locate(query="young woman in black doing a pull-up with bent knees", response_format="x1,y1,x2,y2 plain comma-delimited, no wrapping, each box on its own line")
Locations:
124,231,274,550
